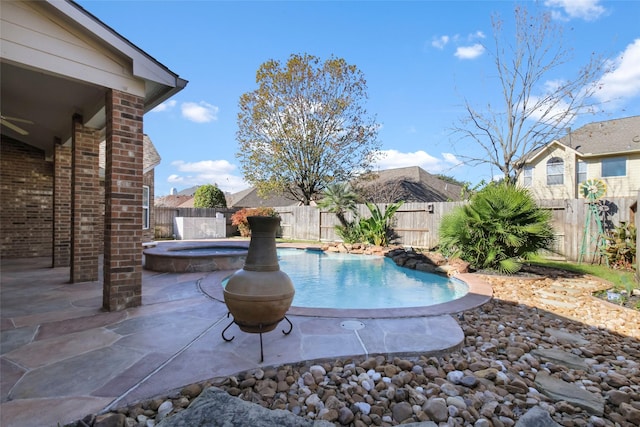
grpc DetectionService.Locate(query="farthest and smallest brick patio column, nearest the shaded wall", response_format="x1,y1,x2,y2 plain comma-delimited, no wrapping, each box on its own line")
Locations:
52,139,73,267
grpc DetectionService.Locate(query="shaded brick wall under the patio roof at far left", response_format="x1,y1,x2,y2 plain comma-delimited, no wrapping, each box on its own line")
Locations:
0,137,53,258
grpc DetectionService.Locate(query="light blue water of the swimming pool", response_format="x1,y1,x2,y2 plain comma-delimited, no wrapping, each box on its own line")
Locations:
229,249,468,309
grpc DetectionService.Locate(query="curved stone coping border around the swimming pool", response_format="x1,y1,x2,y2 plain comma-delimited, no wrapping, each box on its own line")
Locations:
200,244,493,319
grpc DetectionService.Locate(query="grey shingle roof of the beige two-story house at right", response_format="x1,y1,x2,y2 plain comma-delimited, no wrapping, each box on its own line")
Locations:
526,116,640,163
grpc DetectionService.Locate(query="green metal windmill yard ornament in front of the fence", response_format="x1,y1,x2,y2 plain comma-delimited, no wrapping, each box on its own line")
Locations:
578,179,608,263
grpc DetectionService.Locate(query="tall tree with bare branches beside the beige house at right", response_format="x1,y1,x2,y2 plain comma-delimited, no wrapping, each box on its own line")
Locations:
453,6,605,183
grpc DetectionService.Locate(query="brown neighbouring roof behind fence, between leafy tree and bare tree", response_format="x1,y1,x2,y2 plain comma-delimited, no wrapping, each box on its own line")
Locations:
354,166,463,202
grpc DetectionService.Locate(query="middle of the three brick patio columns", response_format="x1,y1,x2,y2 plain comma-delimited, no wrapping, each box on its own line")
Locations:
71,115,102,283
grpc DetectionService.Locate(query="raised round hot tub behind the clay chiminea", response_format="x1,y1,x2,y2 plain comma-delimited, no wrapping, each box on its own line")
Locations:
143,241,249,273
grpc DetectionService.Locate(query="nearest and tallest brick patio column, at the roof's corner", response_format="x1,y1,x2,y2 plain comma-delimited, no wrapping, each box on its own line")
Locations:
102,90,144,311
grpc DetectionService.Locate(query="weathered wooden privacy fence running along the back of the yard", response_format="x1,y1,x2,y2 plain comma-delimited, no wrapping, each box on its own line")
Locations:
155,197,636,261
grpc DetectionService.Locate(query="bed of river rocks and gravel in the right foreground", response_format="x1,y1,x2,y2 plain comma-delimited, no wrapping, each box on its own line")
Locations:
77,264,640,427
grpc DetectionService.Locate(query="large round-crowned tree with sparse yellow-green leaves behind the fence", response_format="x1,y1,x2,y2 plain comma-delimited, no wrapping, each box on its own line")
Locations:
236,54,379,205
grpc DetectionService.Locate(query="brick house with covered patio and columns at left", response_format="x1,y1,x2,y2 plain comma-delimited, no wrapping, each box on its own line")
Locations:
0,0,187,311
